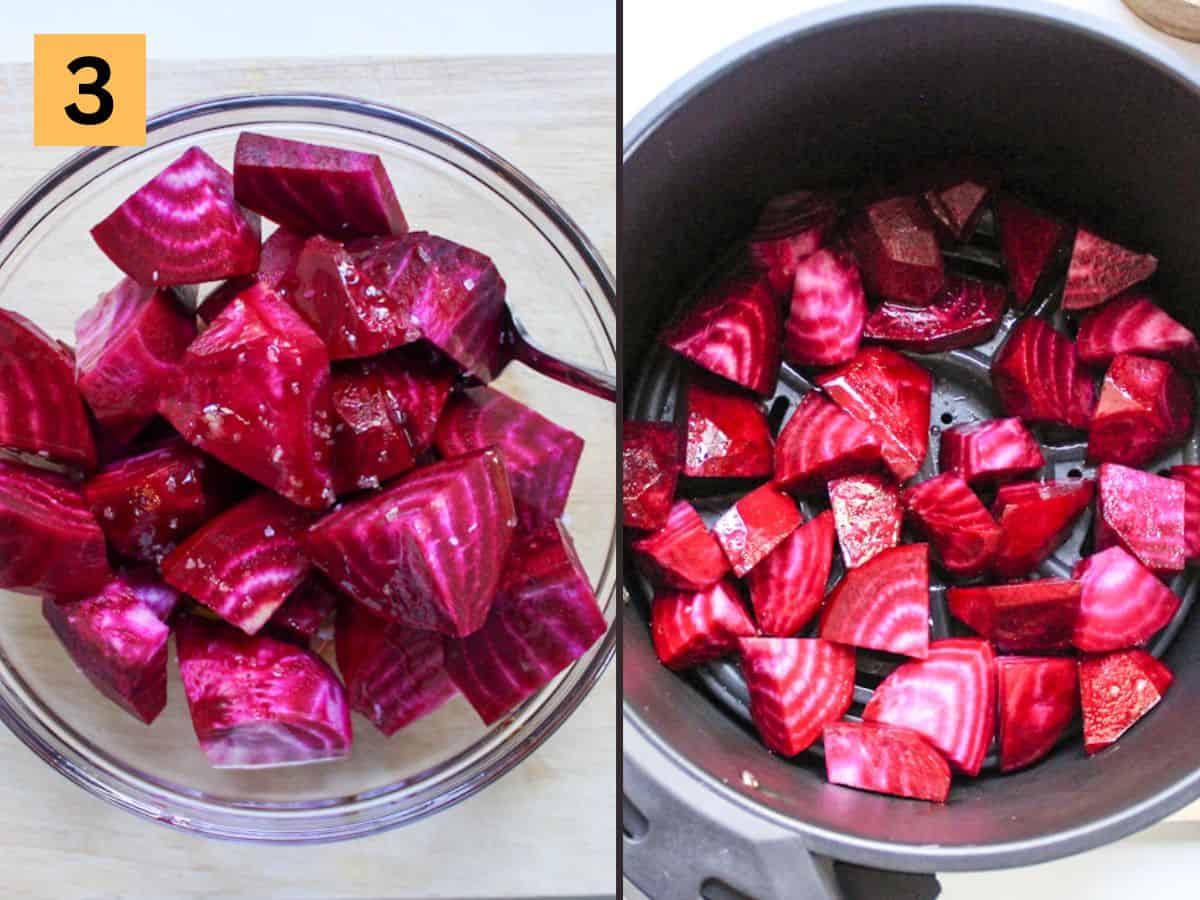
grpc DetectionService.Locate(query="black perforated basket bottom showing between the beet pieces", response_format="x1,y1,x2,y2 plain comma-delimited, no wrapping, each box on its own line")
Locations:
625,207,1200,772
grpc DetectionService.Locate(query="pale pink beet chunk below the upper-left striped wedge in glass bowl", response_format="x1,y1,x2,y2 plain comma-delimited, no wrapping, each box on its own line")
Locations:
76,278,196,443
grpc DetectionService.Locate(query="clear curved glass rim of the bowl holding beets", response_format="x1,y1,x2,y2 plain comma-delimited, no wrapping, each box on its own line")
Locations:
0,92,617,844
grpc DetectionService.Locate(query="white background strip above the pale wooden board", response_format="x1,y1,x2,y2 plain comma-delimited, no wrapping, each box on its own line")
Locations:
0,0,617,62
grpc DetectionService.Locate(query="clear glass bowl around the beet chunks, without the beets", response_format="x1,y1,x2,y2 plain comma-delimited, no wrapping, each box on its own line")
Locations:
0,95,617,842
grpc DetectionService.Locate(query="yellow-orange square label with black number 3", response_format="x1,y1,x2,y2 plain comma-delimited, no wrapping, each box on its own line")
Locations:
34,35,146,146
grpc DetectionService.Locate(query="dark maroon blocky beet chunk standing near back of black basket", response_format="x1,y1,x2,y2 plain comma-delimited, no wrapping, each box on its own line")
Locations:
850,197,946,306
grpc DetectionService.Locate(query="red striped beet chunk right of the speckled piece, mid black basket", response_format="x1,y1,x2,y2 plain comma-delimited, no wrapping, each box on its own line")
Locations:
902,472,1001,578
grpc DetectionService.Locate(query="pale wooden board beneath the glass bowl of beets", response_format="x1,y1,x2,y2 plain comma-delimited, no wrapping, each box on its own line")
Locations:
0,56,617,900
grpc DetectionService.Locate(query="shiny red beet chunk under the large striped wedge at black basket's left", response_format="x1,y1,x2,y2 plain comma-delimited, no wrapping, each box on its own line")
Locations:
677,378,774,478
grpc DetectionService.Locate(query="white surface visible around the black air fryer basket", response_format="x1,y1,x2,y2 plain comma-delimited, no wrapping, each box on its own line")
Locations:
622,0,1200,900
